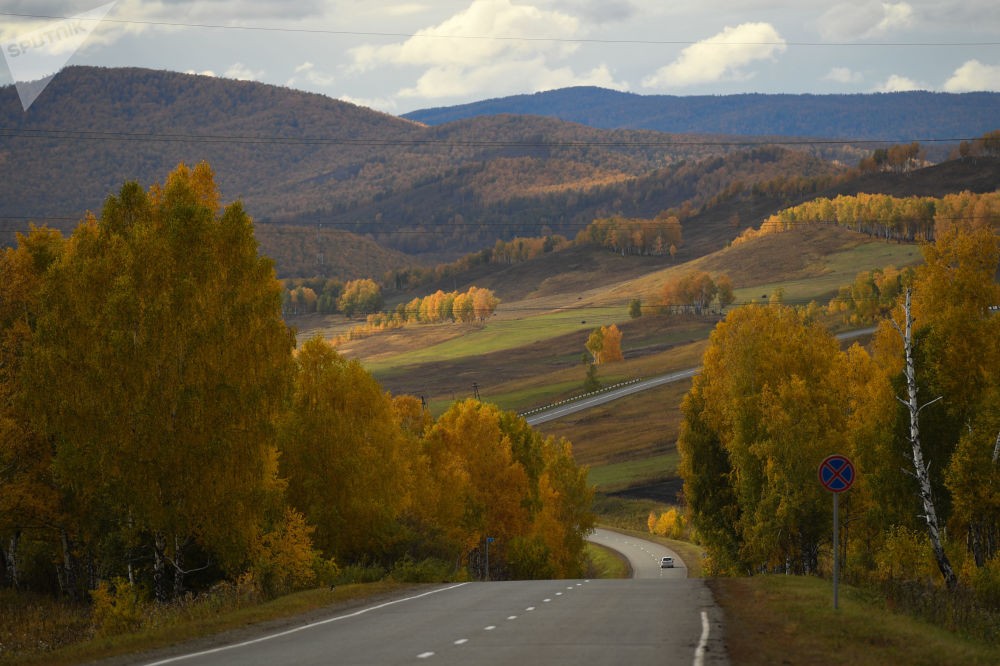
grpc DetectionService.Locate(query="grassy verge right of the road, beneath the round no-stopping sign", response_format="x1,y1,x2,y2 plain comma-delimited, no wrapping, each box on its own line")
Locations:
709,575,1000,666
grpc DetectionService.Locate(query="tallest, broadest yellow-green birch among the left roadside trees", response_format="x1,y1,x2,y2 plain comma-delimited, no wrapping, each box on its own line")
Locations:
26,163,293,600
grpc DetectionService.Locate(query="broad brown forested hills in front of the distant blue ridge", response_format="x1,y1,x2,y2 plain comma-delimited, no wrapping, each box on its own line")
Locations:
0,67,863,266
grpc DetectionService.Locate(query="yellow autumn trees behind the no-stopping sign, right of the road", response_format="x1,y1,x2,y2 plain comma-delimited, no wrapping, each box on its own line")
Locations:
678,224,1000,608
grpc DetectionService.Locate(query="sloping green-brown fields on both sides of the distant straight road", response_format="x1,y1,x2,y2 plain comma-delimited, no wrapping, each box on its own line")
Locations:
286,227,920,498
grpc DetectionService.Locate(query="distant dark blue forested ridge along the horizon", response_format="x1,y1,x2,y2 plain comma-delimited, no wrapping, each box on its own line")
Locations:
403,87,1000,142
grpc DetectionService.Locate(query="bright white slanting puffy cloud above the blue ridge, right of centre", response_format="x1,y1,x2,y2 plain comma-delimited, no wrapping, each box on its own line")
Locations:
642,23,787,88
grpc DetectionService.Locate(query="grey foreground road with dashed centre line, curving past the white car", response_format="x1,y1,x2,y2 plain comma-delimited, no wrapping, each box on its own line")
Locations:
134,530,728,666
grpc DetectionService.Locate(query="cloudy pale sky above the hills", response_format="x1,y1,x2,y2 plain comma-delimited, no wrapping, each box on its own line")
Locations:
0,0,1000,117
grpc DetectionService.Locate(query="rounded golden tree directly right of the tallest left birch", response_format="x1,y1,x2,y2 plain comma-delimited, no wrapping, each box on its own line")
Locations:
281,337,410,561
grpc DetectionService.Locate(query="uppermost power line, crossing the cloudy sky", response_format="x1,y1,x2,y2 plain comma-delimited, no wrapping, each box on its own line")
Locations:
0,12,1000,48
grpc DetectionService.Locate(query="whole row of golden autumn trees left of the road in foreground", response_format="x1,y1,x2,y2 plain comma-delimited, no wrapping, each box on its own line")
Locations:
0,163,593,601
